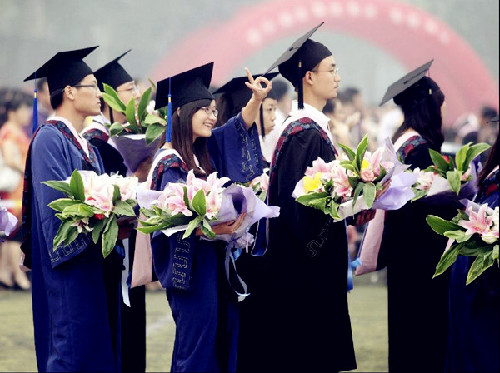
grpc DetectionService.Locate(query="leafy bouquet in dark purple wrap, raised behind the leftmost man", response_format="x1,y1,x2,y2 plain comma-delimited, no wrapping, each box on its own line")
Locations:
102,83,166,172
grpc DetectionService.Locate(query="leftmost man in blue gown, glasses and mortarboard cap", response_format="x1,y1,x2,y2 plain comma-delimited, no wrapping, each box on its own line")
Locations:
22,47,130,372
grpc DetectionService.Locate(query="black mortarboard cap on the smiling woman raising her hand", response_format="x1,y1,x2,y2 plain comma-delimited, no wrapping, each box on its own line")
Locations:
155,62,214,110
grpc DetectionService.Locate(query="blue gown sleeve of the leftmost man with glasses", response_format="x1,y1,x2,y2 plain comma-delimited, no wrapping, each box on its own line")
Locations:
31,129,94,268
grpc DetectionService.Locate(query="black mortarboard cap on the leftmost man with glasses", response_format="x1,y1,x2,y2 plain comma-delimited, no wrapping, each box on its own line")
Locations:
24,46,97,93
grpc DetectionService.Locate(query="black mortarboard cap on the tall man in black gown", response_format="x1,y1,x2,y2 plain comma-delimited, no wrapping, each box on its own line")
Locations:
266,22,332,109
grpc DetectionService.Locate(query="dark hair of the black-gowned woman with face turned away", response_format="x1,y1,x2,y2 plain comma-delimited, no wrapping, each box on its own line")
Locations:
393,76,445,152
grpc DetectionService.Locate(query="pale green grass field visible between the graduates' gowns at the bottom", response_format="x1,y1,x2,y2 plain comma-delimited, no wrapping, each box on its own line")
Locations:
0,275,387,372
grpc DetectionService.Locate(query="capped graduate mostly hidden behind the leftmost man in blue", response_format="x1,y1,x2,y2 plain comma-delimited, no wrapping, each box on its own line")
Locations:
82,50,147,372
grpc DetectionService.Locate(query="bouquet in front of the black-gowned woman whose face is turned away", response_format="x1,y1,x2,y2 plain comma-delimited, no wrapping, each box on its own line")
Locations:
413,143,490,201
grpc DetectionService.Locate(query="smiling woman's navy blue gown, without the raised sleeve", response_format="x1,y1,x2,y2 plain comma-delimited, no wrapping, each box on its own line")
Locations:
151,155,237,372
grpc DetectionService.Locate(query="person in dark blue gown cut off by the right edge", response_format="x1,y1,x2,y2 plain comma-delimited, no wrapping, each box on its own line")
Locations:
445,129,500,373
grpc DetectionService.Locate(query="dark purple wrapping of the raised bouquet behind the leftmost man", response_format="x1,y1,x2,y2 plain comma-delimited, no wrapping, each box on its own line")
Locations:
113,134,161,172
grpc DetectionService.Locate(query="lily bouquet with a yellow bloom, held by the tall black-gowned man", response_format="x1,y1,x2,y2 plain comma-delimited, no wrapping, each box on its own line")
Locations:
293,136,416,220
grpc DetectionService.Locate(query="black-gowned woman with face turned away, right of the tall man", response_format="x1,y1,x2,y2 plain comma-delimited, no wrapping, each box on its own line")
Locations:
376,61,468,372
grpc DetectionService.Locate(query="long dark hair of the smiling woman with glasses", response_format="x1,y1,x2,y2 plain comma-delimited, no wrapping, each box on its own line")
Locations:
172,100,213,177
